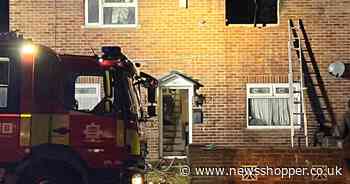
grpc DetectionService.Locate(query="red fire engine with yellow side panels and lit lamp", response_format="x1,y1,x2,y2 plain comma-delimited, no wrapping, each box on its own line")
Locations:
0,32,158,184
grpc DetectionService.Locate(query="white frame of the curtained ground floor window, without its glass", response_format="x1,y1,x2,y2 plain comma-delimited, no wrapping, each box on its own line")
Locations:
246,83,300,129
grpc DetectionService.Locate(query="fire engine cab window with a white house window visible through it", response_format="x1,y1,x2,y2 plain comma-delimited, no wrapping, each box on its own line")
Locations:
75,76,104,111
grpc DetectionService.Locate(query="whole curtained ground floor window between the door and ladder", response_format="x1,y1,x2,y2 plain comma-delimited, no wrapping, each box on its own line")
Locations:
247,83,299,128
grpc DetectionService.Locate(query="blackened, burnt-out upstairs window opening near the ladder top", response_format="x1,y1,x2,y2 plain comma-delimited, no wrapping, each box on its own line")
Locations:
226,0,279,26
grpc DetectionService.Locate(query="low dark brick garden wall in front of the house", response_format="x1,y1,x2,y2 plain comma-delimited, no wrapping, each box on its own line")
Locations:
189,145,350,184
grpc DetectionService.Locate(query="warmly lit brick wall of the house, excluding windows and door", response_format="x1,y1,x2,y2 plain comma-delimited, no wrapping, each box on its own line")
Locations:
10,0,350,158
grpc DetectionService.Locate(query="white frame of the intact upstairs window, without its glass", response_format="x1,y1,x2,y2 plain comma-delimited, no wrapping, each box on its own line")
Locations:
85,0,138,28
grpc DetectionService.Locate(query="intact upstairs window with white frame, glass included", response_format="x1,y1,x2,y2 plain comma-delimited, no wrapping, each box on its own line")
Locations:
85,0,137,27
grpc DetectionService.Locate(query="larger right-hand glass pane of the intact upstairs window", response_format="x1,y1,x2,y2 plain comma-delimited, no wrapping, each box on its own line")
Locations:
103,7,135,24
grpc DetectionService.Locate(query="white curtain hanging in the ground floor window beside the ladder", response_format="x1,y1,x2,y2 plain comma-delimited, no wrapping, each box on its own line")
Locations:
249,98,289,126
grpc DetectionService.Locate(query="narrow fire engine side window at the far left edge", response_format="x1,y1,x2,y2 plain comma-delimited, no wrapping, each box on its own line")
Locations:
0,57,10,108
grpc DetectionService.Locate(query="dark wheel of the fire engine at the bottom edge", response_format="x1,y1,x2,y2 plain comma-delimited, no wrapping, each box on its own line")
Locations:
17,160,83,184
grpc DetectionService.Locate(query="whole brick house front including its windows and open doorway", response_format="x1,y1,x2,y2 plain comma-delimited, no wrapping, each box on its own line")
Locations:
10,0,350,159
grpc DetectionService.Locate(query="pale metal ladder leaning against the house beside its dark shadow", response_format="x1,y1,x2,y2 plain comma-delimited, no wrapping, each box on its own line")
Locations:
288,20,309,147
